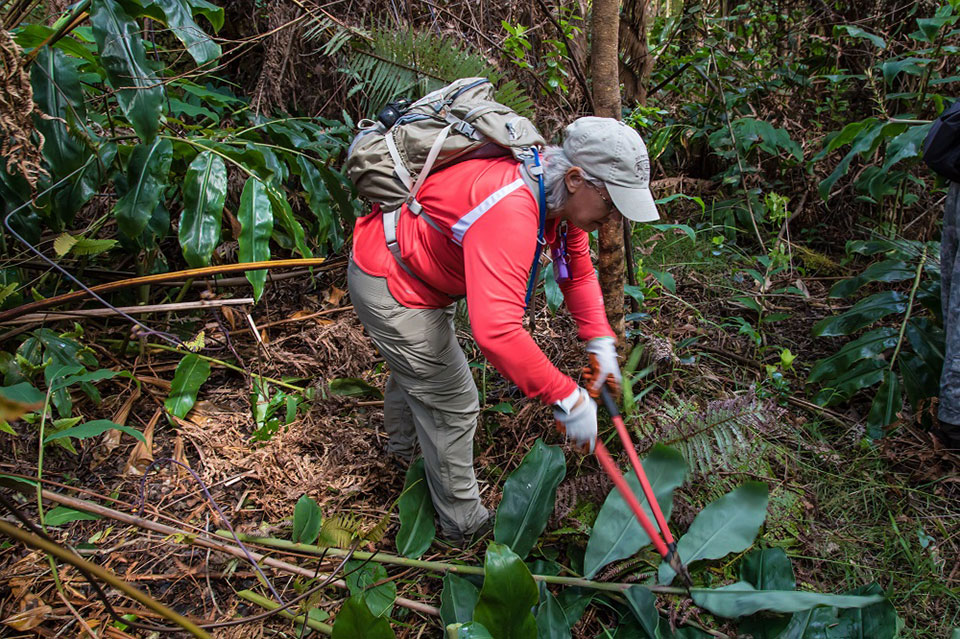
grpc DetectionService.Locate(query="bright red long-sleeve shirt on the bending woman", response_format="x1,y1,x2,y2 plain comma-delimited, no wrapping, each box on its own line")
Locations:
353,158,613,404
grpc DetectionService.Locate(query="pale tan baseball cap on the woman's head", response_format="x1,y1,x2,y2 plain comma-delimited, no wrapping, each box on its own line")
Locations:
563,116,660,222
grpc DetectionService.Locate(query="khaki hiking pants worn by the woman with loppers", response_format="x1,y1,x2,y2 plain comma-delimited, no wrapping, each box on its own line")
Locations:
347,259,489,540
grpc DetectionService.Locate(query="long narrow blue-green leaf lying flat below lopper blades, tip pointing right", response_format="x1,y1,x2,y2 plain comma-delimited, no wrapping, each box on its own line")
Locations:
690,581,884,619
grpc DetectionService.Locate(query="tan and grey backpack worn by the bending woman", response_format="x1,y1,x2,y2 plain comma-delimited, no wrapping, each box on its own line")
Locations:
344,78,546,306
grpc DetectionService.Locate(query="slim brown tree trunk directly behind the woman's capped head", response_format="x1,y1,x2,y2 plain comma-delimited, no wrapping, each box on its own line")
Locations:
590,0,625,344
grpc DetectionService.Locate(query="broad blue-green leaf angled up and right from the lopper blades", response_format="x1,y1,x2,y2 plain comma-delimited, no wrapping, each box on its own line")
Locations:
660,482,769,583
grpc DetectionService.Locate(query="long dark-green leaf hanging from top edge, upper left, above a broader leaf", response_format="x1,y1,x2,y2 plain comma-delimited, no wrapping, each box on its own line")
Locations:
90,0,164,141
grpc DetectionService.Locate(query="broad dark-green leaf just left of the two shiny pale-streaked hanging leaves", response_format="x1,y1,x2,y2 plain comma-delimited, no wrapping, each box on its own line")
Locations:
113,138,173,239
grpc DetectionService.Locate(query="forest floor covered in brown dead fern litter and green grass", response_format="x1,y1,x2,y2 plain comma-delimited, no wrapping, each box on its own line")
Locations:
0,228,960,639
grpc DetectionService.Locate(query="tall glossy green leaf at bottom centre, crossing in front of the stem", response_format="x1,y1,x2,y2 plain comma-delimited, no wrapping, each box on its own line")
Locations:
473,542,537,639
